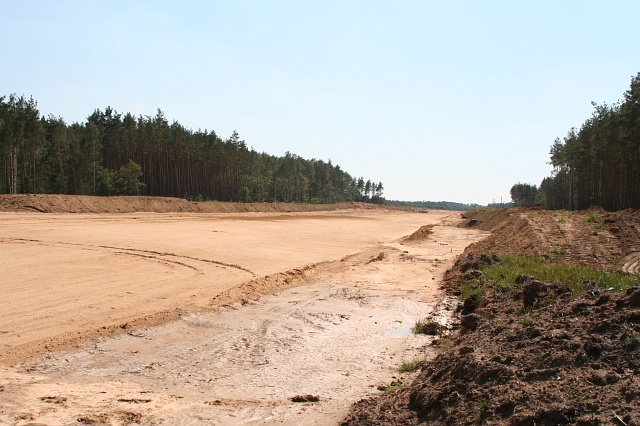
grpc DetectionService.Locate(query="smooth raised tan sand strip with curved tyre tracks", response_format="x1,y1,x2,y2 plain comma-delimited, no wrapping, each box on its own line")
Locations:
0,210,457,363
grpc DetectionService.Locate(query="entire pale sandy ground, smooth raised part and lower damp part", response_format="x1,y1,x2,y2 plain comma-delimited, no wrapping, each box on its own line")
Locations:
0,210,484,425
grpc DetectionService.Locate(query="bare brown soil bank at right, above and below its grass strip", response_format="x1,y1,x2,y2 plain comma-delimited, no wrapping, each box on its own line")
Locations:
343,208,640,425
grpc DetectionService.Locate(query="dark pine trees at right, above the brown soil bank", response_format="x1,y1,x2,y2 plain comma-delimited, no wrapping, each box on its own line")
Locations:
511,73,640,211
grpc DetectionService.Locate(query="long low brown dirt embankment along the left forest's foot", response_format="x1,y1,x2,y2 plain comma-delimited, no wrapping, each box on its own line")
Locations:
0,194,388,213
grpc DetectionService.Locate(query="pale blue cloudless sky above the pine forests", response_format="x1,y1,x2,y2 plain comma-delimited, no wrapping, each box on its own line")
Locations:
0,0,640,204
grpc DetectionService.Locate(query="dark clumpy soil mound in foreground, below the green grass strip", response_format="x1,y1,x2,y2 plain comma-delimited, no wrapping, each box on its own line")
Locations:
343,287,640,425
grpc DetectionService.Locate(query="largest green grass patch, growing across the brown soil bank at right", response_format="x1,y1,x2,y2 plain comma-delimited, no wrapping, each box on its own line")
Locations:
462,255,640,299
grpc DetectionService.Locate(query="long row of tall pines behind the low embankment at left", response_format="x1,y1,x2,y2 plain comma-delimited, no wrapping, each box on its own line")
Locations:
0,95,384,203
